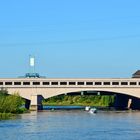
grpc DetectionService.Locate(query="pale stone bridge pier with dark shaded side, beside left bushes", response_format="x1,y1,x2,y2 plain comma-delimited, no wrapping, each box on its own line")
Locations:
30,95,43,111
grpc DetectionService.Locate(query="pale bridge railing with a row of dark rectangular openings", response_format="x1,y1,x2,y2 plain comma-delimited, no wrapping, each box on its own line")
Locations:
0,79,140,88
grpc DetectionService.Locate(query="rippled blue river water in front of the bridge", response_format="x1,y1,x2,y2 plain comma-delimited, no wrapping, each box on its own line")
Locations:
0,110,140,140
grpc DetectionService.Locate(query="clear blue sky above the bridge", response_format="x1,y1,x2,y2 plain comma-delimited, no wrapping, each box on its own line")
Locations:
0,0,140,78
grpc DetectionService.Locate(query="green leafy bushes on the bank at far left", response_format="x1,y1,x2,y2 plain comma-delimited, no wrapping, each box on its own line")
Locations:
0,90,25,120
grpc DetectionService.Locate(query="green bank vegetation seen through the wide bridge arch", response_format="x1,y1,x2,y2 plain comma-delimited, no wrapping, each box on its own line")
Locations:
43,95,114,107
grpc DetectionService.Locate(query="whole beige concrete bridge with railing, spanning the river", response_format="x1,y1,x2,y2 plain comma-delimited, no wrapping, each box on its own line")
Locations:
0,78,140,110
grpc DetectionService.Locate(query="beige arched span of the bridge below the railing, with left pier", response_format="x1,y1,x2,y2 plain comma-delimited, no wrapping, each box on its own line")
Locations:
7,87,140,109
